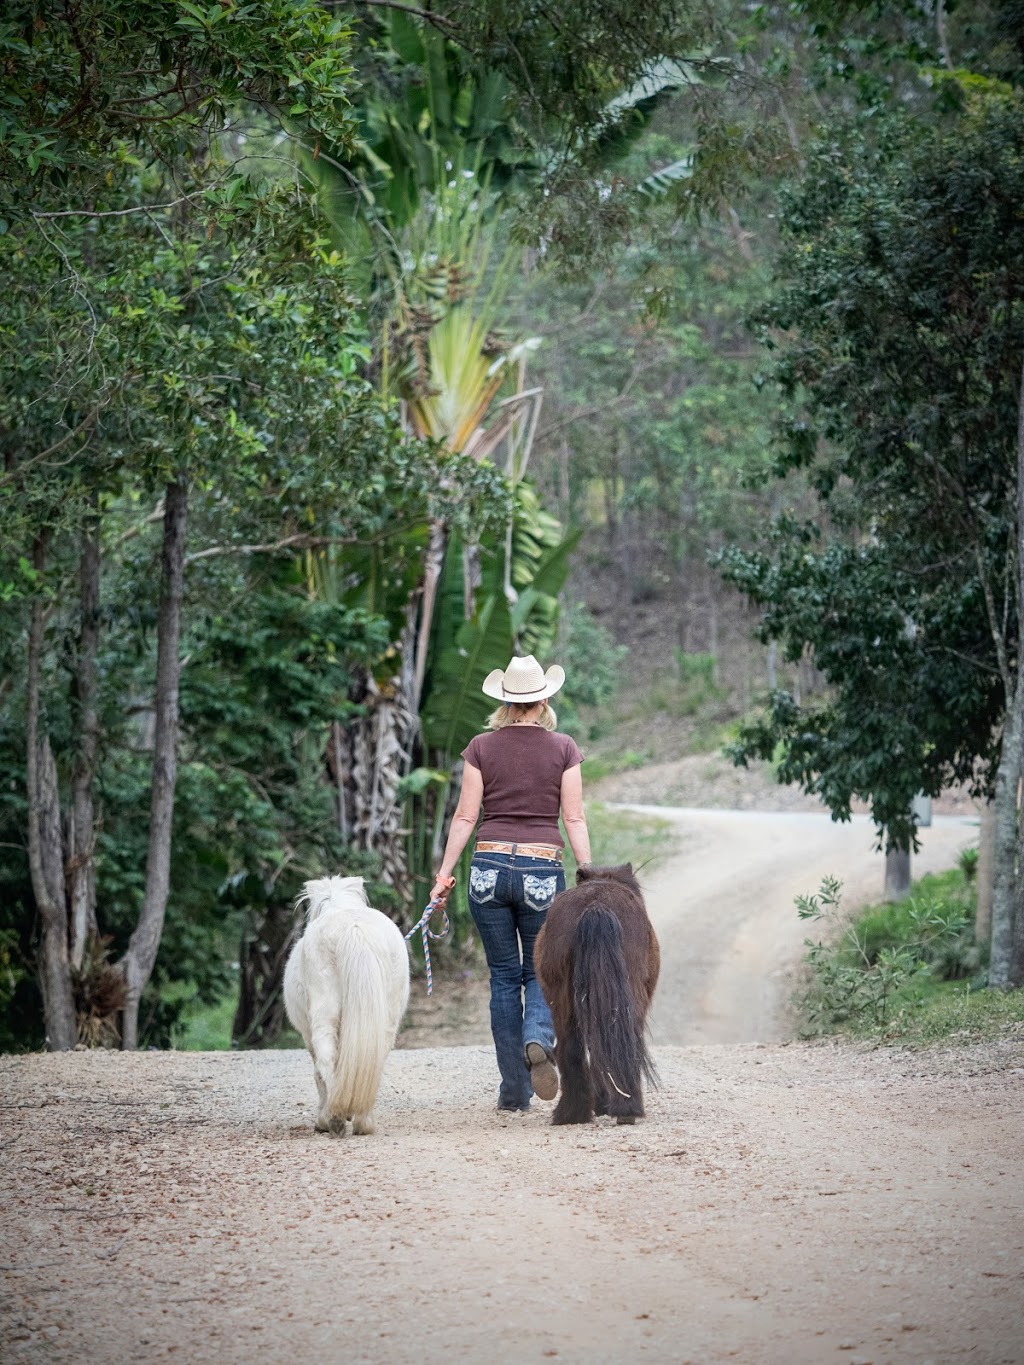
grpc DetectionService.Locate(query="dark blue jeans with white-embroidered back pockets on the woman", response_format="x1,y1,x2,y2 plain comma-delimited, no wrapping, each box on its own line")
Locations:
470,853,565,1110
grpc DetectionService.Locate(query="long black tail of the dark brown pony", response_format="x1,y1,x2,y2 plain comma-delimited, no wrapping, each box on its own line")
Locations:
572,905,658,1115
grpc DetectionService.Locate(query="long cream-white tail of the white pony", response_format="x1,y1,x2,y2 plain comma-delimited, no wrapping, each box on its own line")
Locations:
328,925,395,1122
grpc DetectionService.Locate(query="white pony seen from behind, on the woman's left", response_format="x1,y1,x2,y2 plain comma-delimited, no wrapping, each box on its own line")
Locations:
284,876,408,1137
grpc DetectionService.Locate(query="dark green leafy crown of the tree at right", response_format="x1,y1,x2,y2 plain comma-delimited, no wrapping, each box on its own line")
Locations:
724,96,1024,846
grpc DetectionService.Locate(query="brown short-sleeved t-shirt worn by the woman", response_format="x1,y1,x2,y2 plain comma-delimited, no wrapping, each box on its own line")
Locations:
463,725,583,848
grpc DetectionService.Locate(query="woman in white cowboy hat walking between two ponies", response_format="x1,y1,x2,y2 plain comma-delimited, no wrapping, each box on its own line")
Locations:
431,654,590,1111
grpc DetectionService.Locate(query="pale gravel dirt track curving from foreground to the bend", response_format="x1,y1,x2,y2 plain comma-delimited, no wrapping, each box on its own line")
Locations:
0,812,1024,1365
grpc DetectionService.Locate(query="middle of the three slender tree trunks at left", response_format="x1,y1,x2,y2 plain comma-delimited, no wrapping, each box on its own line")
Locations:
68,510,100,972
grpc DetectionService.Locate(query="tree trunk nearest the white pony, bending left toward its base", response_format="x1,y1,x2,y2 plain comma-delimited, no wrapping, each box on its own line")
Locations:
120,476,188,1050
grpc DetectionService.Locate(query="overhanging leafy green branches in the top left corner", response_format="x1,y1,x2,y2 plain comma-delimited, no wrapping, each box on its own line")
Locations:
0,0,352,217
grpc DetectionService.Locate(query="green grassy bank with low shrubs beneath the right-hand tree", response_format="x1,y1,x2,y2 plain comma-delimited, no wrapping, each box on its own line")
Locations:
797,865,1024,1047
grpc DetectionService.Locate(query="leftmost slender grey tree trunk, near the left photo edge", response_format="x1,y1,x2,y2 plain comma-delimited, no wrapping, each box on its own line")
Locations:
26,538,78,1052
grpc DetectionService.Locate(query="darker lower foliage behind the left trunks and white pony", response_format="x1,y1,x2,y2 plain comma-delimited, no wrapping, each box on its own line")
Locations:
0,539,409,1047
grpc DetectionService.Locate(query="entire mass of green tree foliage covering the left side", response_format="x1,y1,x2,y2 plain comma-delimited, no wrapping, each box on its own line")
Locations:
0,0,516,1041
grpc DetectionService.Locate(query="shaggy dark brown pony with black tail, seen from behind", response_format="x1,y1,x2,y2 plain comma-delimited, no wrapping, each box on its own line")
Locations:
534,863,661,1123
